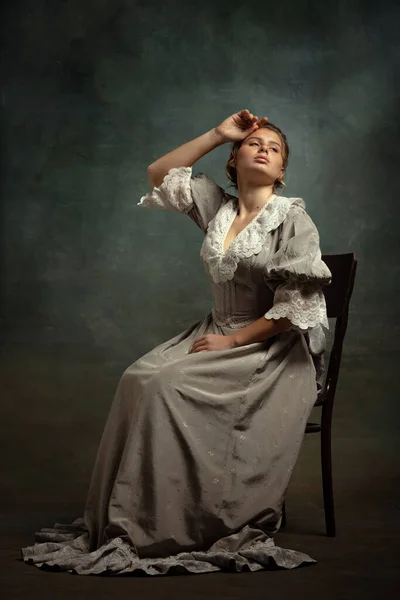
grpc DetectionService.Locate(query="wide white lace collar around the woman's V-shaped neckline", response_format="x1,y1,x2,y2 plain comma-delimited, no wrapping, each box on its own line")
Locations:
200,194,305,283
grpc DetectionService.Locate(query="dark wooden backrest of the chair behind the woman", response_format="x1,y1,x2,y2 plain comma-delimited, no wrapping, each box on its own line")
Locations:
316,253,357,410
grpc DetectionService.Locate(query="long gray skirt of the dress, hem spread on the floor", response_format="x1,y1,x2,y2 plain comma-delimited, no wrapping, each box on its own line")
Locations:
22,313,317,575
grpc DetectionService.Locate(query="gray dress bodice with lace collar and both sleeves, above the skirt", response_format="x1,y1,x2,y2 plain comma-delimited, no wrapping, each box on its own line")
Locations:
138,167,331,332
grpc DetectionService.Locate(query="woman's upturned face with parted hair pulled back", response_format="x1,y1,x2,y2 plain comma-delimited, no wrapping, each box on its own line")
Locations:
234,128,285,185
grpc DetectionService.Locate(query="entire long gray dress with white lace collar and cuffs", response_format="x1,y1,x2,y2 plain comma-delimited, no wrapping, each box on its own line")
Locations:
22,167,331,575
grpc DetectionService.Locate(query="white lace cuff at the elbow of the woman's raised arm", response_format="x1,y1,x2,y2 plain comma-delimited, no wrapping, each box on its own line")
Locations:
137,167,193,212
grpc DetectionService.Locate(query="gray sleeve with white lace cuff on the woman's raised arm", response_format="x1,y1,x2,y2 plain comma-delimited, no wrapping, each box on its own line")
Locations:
138,167,225,232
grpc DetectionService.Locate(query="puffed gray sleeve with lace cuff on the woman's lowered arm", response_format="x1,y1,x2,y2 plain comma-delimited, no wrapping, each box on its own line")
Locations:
264,206,332,332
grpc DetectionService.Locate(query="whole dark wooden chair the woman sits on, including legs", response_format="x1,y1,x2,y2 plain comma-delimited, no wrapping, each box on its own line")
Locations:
282,254,357,537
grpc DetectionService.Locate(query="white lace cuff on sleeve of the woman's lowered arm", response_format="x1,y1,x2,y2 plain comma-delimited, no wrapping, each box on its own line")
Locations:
264,282,329,332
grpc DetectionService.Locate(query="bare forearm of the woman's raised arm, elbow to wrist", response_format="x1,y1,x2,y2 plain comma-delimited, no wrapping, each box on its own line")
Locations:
147,128,225,186
